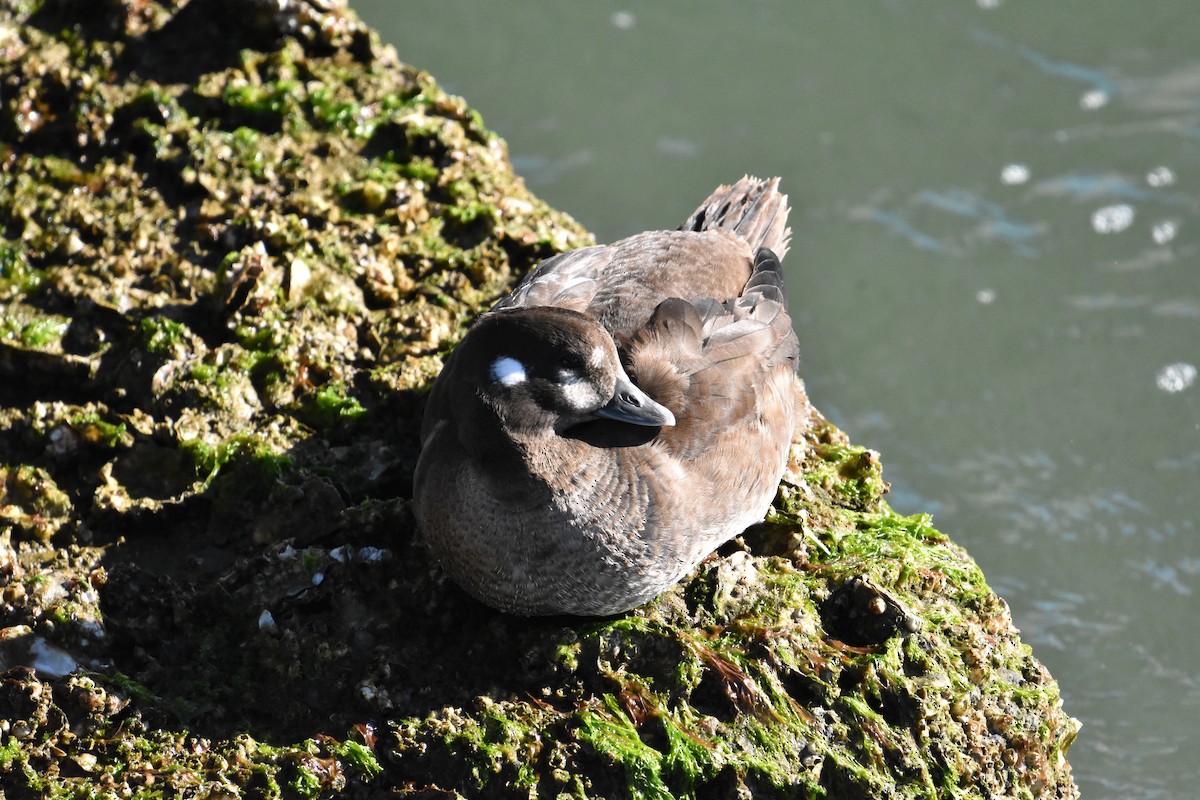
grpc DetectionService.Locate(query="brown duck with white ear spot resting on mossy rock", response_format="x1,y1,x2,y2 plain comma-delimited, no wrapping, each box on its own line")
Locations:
413,178,799,615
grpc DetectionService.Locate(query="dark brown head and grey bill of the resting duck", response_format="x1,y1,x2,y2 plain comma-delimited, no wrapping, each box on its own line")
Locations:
446,306,676,435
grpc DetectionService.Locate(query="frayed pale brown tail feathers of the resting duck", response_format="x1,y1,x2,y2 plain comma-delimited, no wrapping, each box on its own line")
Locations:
679,175,792,259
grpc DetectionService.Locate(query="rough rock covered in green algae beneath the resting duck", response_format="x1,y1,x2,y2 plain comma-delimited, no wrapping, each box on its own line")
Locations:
0,0,1078,798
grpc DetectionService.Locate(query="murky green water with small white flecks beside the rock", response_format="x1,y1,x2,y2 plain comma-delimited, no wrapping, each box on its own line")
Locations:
355,0,1200,800
